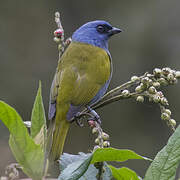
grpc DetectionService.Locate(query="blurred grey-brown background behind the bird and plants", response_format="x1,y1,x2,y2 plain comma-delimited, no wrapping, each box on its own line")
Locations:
0,0,180,176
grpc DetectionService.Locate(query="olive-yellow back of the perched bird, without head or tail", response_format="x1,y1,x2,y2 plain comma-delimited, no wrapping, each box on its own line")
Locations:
58,42,111,105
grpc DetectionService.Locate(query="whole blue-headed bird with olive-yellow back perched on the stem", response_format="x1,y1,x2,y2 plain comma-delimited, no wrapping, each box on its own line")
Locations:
49,20,121,161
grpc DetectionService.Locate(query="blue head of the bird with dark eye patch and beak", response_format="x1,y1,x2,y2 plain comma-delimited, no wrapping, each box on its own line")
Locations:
72,20,122,51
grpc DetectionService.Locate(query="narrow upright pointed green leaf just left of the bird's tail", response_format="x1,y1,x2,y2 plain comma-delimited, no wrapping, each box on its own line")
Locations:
31,82,46,144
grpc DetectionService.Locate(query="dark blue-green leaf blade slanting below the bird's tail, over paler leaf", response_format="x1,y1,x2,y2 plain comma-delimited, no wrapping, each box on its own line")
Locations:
58,154,92,180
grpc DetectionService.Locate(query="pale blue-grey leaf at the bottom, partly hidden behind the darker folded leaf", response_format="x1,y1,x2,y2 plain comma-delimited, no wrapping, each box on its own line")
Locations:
60,153,112,180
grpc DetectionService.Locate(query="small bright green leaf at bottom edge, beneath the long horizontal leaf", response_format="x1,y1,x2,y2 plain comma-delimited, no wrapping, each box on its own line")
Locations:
109,165,140,180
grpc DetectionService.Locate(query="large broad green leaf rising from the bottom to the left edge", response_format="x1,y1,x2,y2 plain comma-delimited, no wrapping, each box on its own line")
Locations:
0,101,44,180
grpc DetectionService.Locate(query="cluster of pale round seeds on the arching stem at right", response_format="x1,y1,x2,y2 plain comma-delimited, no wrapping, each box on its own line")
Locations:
131,67,180,129
